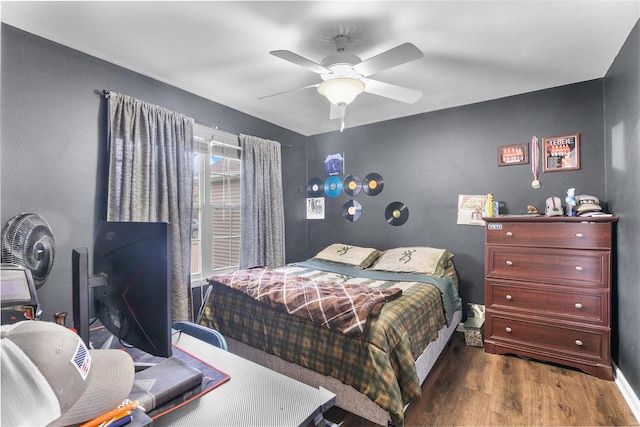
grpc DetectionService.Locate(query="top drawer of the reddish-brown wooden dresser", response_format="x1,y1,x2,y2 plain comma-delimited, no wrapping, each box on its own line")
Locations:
486,221,611,249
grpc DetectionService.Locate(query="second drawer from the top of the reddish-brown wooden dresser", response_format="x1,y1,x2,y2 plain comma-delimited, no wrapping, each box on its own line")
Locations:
485,245,610,287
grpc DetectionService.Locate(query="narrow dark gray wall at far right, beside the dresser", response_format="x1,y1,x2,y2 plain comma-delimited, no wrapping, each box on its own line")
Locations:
604,21,640,402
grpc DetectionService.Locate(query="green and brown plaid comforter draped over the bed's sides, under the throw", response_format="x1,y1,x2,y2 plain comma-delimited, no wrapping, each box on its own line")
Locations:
200,264,457,426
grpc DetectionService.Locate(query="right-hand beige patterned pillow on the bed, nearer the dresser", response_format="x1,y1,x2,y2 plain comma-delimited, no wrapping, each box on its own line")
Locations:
371,246,453,277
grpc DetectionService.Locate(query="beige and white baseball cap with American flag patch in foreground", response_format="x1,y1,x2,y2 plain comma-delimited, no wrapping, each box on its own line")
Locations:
0,320,135,427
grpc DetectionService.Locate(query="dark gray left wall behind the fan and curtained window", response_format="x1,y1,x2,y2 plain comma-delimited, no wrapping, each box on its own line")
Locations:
0,24,306,323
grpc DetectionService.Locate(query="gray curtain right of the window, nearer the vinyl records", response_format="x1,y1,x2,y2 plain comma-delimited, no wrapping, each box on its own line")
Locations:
240,135,285,268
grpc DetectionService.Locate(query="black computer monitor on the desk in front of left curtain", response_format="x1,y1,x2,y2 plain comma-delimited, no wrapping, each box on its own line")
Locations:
72,221,171,357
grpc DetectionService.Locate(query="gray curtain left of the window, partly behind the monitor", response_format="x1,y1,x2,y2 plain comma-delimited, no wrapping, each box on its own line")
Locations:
107,92,193,321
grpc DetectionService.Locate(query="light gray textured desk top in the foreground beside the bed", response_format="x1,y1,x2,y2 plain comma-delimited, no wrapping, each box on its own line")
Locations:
153,333,336,427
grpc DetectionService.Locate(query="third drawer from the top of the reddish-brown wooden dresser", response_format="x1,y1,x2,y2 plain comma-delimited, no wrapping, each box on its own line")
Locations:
485,280,609,326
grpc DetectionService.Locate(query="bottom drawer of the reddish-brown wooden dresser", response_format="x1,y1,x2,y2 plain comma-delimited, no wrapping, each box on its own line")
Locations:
485,315,610,364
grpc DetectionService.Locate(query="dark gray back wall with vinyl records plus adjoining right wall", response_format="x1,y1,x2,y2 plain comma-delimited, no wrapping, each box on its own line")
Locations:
300,17,640,404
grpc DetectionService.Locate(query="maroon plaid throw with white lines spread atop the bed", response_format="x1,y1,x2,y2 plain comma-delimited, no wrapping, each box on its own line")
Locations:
215,267,402,337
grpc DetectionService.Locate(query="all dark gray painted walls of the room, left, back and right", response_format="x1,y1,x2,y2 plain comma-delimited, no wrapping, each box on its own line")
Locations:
0,18,640,402
